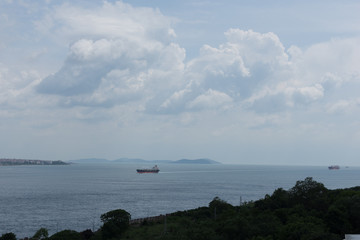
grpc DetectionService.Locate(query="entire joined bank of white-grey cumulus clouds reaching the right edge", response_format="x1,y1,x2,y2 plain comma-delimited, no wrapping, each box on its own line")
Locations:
36,2,360,119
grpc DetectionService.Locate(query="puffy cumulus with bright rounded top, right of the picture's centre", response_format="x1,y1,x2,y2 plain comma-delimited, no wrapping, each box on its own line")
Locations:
161,29,296,112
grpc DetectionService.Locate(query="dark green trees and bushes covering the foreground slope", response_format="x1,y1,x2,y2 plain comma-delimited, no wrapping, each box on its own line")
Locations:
0,178,360,240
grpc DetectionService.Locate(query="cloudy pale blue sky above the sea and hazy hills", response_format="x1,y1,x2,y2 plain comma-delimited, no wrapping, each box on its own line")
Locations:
0,0,360,166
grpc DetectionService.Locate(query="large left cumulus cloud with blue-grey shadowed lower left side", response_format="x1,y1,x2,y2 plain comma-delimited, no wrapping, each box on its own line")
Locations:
37,2,185,106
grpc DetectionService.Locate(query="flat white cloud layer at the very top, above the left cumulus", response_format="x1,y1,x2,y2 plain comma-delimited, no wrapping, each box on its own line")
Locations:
37,1,174,45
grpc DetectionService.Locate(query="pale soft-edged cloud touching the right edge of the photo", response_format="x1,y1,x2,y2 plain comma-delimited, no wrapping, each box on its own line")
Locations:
240,38,360,112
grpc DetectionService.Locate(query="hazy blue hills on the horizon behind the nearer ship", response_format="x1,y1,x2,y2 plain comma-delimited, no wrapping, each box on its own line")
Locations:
69,158,221,164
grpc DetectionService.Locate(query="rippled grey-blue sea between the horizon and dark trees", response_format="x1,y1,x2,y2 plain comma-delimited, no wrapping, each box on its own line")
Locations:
0,163,360,238
